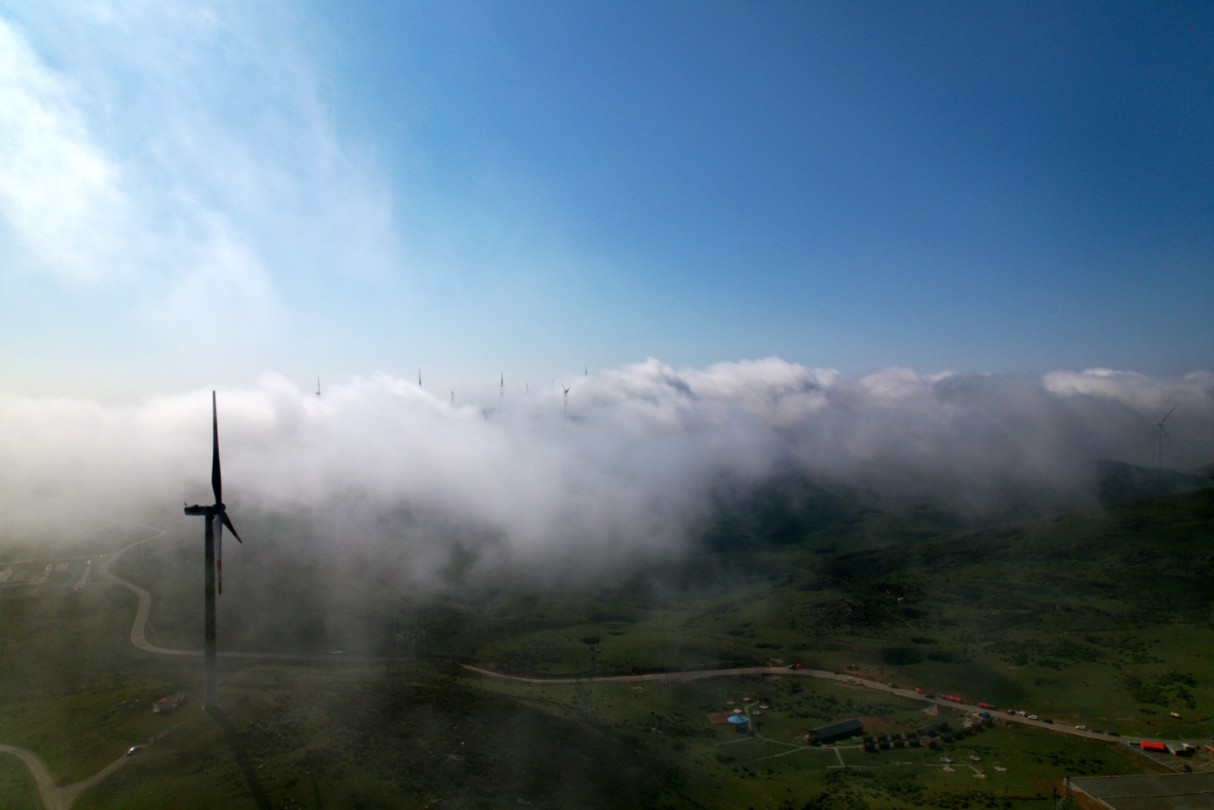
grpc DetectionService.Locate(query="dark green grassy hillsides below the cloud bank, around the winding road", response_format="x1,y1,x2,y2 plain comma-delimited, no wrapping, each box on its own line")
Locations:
0,489,1214,808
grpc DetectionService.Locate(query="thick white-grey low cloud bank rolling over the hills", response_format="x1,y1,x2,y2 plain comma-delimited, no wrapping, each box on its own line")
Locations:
0,358,1214,576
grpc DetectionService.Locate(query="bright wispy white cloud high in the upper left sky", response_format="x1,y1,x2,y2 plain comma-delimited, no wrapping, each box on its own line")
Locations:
0,2,399,349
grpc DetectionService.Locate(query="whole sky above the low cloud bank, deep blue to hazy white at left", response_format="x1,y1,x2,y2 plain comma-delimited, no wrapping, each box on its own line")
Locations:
0,1,1214,398
